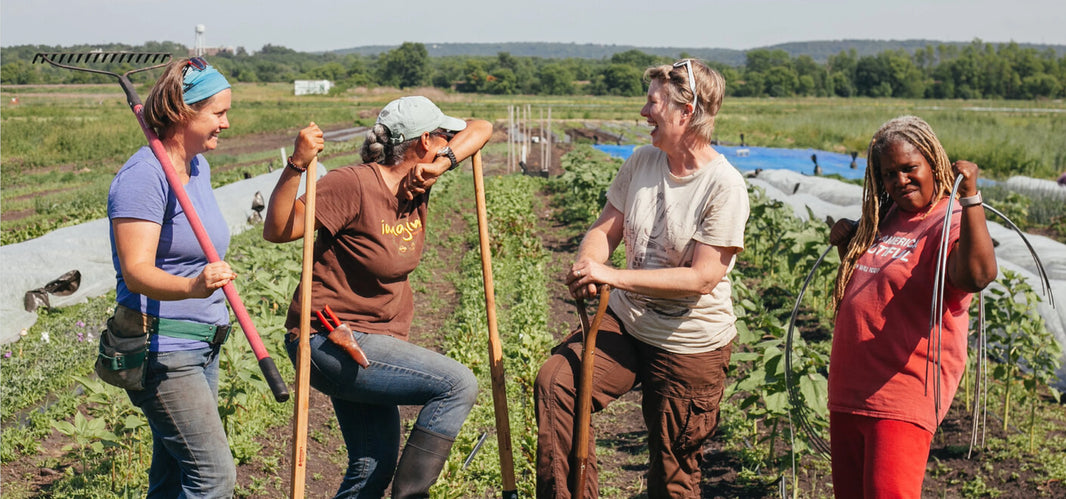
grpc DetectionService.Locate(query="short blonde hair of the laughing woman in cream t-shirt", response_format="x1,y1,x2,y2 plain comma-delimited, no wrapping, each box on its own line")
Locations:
644,59,726,143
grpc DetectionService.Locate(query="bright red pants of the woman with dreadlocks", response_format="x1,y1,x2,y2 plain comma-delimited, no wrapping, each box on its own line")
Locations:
829,413,933,499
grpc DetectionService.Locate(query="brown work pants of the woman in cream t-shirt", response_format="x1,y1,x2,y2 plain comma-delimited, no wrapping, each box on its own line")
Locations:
533,313,732,499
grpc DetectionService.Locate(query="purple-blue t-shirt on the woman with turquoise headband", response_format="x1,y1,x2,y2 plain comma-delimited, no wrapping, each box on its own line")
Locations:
108,146,229,352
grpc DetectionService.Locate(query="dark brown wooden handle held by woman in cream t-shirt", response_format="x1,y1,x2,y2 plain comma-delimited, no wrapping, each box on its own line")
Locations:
570,285,611,499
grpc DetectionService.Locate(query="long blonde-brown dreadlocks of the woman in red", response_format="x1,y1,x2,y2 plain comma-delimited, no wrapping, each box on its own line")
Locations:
833,116,952,306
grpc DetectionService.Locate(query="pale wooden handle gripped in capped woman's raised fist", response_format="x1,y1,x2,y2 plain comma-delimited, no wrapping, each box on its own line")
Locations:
289,157,319,499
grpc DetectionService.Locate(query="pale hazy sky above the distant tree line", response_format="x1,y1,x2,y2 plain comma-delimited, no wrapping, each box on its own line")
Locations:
0,0,1066,51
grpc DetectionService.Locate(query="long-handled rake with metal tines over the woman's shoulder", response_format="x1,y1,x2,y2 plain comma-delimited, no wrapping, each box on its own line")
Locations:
33,51,289,402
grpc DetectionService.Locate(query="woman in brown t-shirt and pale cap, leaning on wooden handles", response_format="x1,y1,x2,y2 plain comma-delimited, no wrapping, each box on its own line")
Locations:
263,97,492,497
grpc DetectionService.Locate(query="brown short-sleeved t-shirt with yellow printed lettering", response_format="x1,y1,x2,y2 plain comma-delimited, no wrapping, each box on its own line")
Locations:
285,163,429,340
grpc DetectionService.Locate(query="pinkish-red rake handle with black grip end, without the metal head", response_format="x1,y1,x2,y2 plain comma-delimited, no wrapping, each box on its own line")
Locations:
131,104,289,402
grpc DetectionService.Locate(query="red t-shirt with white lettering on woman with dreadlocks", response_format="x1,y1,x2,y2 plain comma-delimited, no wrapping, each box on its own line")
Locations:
829,198,972,432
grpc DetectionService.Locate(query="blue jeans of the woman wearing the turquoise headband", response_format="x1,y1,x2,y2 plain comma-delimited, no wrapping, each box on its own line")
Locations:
126,347,237,498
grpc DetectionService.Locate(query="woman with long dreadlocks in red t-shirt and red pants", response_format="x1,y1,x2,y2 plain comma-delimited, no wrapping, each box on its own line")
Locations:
829,116,998,498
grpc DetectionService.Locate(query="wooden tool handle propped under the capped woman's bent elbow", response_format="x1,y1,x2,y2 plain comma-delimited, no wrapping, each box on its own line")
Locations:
471,150,518,499
